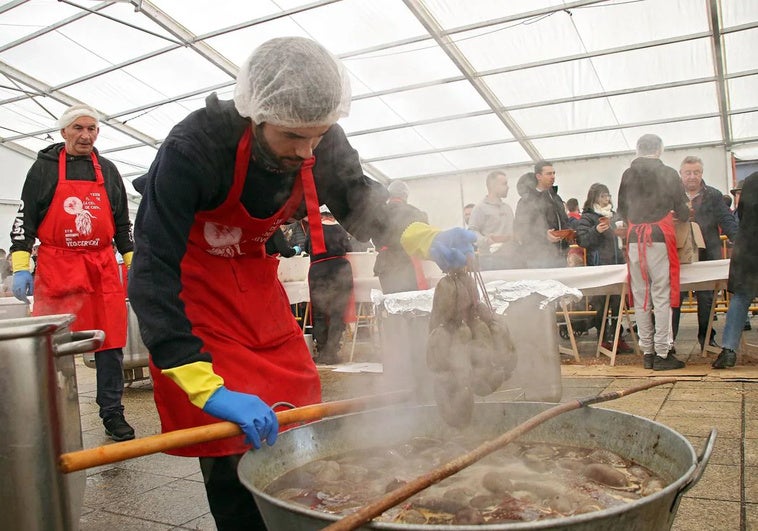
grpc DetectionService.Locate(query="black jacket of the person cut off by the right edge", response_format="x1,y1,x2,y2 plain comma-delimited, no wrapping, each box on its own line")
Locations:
728,172,758,297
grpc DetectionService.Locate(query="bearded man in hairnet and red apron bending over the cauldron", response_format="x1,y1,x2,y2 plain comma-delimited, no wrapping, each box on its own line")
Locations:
129,37,475,529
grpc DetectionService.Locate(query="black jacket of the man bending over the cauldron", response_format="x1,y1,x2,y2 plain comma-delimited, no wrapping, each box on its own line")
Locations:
129,94,416,369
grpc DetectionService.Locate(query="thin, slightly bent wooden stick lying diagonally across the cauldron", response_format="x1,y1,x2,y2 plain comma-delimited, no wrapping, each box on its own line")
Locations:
324,378,676,531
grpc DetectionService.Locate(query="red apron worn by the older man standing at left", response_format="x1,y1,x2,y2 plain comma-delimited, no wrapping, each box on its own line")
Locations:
32,148,126,350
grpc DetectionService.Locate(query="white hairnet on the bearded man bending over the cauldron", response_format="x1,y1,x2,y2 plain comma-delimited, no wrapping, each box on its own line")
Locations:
234,37,350,127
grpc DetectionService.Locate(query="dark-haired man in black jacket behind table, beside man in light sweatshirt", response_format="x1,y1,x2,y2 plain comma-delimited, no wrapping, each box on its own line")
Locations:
513,160,571,269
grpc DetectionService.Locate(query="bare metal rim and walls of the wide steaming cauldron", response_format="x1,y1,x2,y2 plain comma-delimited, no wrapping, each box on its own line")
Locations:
237,402,715,531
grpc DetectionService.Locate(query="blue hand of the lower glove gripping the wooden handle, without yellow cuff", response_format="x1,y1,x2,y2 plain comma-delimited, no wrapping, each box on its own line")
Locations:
203,386,279,450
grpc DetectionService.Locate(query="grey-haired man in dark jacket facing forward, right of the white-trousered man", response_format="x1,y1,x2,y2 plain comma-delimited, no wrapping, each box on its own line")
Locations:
671,156,737,350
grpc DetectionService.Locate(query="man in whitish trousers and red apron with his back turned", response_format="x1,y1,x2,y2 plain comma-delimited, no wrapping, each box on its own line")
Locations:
618,134,690,371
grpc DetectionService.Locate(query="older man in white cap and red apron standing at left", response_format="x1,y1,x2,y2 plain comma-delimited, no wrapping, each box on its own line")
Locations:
11,105,134,441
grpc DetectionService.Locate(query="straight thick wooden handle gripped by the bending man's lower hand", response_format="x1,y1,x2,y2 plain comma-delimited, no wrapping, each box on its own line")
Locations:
58,391,411,473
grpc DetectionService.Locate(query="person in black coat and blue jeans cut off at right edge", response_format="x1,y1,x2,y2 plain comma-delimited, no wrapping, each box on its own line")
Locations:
712,172,758,369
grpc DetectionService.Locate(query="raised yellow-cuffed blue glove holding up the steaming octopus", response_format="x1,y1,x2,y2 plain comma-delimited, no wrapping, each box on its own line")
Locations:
400,222,476,271
